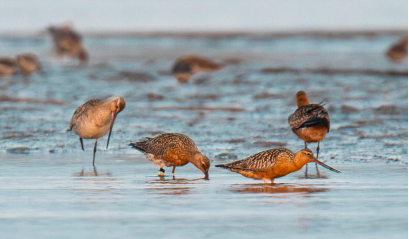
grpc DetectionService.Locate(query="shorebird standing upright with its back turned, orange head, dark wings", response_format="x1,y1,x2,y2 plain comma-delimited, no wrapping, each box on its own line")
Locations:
288,90,331,172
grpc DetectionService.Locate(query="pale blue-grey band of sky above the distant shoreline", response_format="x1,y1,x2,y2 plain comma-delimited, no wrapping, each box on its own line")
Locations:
0,0,408,32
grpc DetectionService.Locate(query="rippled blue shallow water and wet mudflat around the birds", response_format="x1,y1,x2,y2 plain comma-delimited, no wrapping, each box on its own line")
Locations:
0,34,408,238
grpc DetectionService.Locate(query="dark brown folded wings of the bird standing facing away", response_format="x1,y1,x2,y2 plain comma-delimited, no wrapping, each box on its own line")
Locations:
288,103,331,131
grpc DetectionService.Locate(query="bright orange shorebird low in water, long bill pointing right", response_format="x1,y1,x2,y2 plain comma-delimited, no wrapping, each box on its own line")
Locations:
216,148,340,183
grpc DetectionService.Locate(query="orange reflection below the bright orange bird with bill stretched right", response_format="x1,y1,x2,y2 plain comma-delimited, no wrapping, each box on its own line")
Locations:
231,184,328,193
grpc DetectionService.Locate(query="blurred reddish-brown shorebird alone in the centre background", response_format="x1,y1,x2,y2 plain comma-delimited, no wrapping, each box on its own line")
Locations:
172,55,224,83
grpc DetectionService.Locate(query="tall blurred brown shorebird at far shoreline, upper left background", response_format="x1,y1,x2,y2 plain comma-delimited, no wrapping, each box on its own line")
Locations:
48,25,88,63
